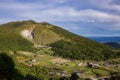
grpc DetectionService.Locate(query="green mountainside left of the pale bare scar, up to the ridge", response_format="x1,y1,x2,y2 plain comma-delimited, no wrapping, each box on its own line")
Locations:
0,21,35,51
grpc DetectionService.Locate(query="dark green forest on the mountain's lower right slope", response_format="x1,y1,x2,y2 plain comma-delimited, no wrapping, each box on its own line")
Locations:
51,40,120,60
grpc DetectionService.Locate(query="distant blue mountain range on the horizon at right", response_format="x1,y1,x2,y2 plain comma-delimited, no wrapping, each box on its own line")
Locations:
88,36,120,43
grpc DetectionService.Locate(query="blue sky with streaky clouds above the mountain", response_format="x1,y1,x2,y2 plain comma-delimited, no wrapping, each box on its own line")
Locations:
0,0,120,36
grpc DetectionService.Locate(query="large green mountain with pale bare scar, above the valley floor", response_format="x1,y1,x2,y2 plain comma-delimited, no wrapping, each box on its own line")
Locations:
0,20,120,60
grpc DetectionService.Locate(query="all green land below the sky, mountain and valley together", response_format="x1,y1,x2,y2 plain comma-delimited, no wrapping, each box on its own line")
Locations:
0,20,120,80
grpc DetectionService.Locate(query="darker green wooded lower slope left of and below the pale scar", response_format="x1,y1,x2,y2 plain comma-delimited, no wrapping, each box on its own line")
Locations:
0,33,36,51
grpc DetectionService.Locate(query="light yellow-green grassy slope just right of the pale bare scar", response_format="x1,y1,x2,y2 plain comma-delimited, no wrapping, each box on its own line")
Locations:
33,24,61,45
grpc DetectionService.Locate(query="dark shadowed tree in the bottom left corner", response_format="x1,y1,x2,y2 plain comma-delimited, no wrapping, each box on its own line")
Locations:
0,53,23,80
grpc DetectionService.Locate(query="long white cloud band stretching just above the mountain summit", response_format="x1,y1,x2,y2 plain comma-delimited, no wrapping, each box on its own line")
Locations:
19,7,120,23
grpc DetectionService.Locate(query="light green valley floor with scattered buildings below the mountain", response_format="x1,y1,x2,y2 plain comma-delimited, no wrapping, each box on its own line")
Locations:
4,48,120,80
